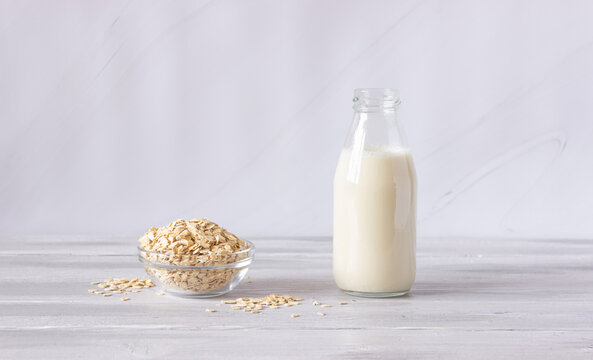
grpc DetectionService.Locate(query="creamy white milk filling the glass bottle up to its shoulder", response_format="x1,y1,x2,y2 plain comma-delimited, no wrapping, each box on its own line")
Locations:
333,148,416,293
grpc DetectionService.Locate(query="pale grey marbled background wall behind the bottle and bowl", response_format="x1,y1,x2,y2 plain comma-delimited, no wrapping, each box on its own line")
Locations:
0,0,593,238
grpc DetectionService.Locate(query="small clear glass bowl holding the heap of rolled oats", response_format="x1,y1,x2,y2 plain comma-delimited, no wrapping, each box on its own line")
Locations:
138,240,255,298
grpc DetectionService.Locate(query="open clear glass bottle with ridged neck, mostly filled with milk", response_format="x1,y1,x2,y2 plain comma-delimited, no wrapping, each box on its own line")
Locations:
333,89,416,297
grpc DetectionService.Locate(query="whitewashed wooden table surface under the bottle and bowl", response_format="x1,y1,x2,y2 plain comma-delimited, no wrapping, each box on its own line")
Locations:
0,238,593,359
